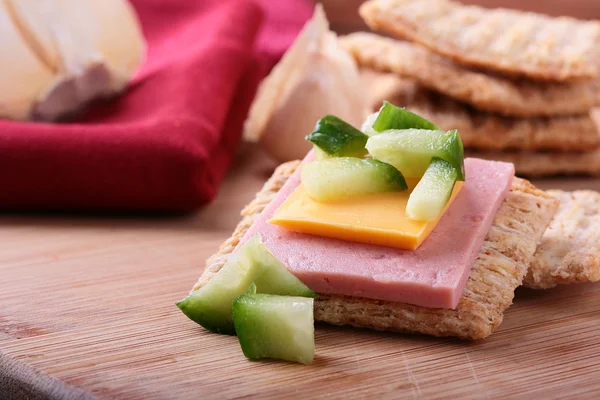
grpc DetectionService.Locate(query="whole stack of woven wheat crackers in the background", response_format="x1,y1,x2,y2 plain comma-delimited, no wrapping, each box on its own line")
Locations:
341,0,600,176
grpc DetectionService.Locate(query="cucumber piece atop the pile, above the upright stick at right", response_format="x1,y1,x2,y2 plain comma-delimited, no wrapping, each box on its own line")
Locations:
367,129,465,181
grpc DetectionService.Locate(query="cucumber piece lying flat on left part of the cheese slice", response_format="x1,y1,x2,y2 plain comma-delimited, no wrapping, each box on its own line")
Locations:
301,157,407,201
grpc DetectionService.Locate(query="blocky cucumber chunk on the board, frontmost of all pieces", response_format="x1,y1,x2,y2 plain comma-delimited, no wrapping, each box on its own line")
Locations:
233,292,315,364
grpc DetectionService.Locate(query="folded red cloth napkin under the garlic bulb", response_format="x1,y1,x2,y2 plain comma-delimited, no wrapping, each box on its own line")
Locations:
0,0,312,211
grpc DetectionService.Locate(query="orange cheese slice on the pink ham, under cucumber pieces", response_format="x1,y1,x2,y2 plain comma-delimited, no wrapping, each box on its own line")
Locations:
268,180,464,250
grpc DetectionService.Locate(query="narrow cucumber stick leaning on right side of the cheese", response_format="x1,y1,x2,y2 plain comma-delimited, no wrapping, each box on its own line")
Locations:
406,157,458,221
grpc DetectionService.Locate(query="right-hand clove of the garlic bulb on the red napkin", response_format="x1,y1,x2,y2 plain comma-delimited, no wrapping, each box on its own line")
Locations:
6,0,145,120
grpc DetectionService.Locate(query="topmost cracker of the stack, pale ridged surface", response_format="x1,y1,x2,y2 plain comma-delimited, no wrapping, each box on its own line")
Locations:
360,0,600,81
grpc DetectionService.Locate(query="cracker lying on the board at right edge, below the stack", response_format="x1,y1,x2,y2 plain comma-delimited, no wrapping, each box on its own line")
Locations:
523,190,600,289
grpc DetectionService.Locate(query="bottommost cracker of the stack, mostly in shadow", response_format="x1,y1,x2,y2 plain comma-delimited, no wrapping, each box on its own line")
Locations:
465,149,600,178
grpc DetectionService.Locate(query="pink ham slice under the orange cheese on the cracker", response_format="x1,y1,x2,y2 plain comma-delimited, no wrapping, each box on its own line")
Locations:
237,158,514,308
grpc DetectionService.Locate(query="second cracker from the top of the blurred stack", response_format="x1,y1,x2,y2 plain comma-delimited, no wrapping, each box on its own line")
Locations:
339,32,600,117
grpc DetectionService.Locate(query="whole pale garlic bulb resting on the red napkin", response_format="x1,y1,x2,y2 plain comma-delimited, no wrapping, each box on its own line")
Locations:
0,0,145,121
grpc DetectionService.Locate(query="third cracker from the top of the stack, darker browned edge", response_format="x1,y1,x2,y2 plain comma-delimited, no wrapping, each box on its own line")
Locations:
361,69,600,154
